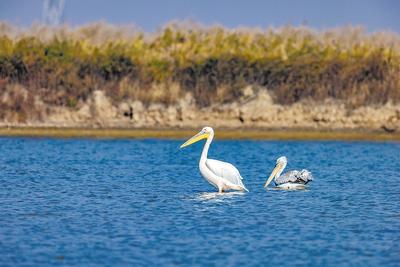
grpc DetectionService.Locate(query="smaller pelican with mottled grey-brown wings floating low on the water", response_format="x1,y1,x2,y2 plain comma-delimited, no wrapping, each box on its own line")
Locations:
264,157,313,189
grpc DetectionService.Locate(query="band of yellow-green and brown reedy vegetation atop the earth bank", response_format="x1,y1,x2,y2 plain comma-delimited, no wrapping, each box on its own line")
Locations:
0,23,400,108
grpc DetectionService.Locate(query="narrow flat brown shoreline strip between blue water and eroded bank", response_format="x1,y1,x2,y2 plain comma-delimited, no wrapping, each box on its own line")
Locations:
0,127,400,141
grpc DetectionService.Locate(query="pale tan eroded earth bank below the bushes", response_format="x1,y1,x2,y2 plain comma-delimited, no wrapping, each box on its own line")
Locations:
0,87,400,133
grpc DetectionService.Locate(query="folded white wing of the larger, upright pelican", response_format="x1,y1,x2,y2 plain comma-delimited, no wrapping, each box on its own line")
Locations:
206,159,244,187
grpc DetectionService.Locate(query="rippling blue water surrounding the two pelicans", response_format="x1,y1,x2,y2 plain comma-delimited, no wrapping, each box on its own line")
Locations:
0,138,400,266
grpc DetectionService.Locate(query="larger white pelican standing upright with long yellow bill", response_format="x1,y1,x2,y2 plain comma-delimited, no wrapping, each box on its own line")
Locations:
180,127,249,193
